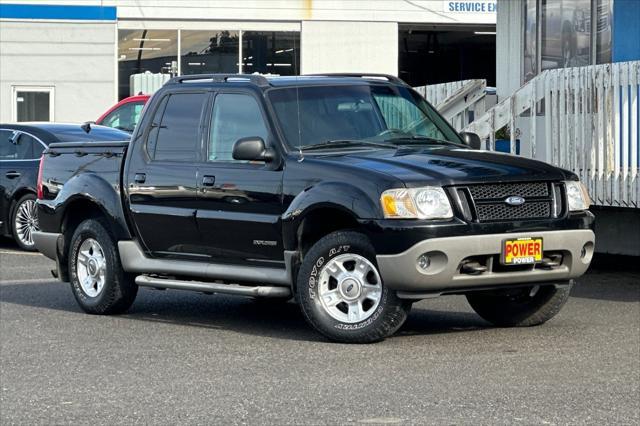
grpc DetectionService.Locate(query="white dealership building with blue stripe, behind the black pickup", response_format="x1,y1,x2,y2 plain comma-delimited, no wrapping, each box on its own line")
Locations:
0,0,496,122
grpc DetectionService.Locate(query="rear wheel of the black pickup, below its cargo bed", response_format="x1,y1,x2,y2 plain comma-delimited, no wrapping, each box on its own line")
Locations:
69,219,138,315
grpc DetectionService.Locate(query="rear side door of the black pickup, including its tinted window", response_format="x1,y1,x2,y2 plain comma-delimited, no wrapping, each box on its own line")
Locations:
124,91,208,258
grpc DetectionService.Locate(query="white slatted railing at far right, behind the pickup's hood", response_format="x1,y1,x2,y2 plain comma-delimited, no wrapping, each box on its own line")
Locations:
464,61,640,208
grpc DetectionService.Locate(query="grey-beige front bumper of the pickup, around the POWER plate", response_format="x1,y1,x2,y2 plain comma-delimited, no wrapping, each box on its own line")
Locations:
377,229,595,293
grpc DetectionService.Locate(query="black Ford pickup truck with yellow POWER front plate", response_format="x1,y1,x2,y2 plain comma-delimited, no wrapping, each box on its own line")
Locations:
34,74,594,342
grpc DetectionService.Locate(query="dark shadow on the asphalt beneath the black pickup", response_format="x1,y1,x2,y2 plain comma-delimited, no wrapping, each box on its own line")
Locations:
0,281,489,342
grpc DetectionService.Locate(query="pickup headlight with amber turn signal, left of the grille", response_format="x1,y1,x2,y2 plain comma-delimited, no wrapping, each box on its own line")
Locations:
380,186,453,219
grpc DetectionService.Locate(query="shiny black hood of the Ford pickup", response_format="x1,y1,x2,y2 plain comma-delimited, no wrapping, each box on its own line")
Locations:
308,146,574,186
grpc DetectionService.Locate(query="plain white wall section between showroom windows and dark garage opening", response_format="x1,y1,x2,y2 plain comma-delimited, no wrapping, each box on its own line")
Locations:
300,21,398,75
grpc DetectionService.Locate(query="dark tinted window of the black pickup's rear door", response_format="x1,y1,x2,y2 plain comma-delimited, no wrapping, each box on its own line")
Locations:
147,93,206,161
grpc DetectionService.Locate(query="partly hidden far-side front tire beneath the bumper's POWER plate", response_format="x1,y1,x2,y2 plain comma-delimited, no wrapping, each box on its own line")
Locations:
467,285,571,327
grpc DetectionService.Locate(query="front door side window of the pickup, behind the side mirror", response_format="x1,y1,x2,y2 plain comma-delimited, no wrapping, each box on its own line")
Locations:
209,93,269,161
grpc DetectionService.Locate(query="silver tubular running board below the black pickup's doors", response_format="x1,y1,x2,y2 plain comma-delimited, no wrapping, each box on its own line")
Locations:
136,275,291,297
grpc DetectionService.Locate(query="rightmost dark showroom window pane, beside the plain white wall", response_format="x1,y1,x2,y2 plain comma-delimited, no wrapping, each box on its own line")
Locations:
242,31,300,75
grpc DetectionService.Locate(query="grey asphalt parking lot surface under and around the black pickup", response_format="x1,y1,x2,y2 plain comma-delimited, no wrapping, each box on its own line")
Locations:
0,240,640,424
